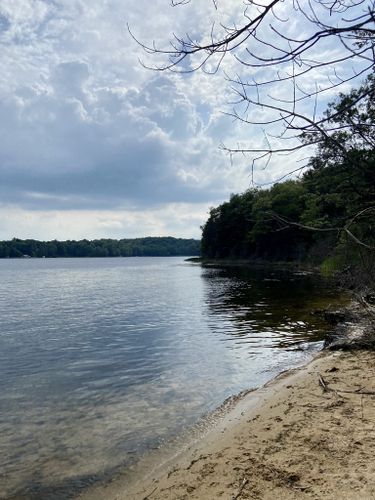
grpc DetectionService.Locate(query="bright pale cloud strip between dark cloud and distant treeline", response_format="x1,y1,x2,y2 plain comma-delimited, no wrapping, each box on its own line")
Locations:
0,203,207,240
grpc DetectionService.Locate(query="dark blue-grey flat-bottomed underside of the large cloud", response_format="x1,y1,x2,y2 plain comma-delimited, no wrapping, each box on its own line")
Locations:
0,140,223,209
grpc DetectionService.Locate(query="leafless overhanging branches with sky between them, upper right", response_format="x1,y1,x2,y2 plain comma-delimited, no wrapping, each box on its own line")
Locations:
129,0,375,174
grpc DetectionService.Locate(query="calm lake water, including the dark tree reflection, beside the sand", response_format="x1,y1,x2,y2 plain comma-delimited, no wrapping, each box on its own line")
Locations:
0,258,346,498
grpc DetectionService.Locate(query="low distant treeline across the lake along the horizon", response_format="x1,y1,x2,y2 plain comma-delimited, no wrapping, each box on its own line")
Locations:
0,237,200,259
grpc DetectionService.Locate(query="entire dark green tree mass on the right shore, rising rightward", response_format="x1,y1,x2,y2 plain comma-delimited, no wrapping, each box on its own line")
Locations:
202,77,375,284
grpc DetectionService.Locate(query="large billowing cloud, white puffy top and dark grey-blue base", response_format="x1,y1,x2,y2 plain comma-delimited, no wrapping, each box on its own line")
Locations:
0,61,229,209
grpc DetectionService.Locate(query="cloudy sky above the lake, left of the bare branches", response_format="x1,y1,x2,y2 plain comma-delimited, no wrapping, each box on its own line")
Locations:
0,0,370,240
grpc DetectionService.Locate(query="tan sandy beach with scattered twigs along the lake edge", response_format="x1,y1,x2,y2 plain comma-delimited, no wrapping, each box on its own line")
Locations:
80,351,375,500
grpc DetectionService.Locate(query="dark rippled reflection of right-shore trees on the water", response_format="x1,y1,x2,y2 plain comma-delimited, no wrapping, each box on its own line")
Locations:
202,266,345,349
